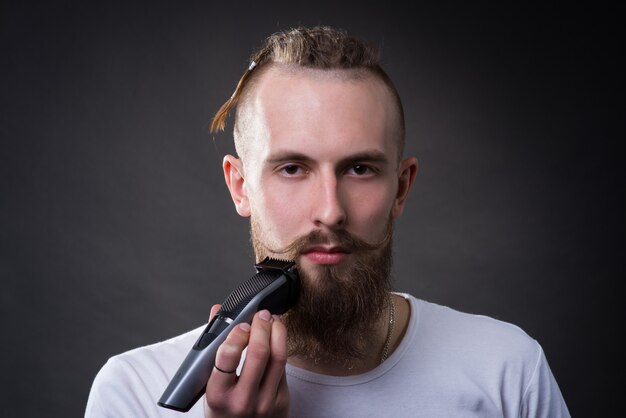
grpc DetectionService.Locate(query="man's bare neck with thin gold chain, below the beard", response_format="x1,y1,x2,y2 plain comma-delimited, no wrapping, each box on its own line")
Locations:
288,294,409,376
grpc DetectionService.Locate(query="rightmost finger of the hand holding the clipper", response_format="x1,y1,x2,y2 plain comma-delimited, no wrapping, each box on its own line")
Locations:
258,317,289,416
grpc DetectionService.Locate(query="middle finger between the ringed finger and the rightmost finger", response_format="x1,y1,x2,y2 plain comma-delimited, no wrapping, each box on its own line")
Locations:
238,309,274,393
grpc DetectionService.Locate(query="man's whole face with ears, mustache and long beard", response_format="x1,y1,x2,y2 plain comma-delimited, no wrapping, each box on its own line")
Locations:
224,69,417,359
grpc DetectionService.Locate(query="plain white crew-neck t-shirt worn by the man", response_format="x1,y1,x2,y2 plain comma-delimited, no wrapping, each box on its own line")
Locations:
85,294,570,418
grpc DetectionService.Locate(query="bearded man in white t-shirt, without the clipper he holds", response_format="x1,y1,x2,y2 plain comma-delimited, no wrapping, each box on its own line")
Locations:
86,27,569,417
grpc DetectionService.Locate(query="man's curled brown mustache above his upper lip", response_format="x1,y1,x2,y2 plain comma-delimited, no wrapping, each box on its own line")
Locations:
267,221,393,260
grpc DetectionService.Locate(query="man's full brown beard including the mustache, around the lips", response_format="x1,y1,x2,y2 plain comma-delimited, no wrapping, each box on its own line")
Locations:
251,217,393,364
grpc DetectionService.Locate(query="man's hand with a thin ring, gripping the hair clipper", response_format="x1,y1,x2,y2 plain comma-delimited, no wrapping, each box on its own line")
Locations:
204,305,289,418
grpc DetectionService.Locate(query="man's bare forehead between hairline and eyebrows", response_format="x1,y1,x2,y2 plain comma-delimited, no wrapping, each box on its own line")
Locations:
237,65,398,163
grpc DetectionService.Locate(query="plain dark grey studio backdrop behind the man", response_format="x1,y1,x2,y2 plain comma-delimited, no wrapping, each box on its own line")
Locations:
0,1,624,417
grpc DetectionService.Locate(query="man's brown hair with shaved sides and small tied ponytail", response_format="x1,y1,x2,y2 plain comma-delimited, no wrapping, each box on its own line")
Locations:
210,26,405,157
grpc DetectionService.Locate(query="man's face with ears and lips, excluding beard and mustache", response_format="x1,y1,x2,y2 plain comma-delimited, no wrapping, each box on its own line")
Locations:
225,69,416,278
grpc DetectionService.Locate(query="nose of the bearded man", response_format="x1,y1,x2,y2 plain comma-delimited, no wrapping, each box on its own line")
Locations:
312,173,346,229
